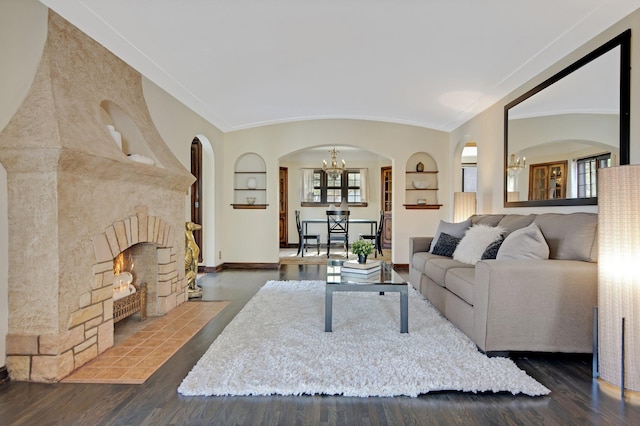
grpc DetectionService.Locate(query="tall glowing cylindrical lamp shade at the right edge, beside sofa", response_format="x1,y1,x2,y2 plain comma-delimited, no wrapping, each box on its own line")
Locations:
598,165,640,391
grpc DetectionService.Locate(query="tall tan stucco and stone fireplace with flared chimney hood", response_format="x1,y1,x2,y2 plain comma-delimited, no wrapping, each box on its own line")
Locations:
0,11,194,382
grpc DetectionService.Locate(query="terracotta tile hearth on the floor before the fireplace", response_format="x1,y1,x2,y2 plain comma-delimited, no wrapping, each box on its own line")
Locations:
62,301,229,384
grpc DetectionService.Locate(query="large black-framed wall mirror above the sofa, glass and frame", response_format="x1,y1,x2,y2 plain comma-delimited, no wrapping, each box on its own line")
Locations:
504,30,631,207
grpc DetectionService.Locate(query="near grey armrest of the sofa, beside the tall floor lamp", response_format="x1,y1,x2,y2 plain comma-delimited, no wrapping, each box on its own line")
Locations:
473,259,598,353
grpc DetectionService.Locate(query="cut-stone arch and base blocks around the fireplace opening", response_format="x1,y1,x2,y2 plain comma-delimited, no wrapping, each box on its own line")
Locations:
7,207,180,381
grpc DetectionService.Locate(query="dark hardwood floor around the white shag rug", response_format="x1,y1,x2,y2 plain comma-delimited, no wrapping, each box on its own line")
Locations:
0,265,640,425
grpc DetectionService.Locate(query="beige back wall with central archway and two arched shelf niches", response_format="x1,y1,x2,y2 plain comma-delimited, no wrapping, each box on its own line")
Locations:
222,120,452,263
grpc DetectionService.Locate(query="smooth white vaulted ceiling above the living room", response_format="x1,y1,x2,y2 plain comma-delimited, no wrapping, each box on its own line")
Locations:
41,0,640,132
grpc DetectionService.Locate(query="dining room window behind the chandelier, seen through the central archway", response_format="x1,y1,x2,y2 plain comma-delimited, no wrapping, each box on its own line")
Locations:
300,169,367,206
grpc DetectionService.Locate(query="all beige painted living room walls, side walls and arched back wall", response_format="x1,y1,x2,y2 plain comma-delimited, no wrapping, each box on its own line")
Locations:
0,0,640,365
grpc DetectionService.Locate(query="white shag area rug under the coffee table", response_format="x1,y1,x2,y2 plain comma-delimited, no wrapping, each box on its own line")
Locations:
178,281,550,397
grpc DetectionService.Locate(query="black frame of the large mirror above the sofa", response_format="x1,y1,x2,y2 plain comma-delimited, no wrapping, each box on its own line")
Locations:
503,29,631,207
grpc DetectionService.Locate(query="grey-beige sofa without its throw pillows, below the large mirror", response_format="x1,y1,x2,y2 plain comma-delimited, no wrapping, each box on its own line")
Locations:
409,213,598,353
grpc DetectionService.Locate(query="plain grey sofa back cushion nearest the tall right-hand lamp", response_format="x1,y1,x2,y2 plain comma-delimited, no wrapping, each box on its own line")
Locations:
534,213,598,262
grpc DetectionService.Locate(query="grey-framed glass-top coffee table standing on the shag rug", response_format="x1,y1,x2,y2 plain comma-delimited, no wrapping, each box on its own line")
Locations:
324,260,409,333
